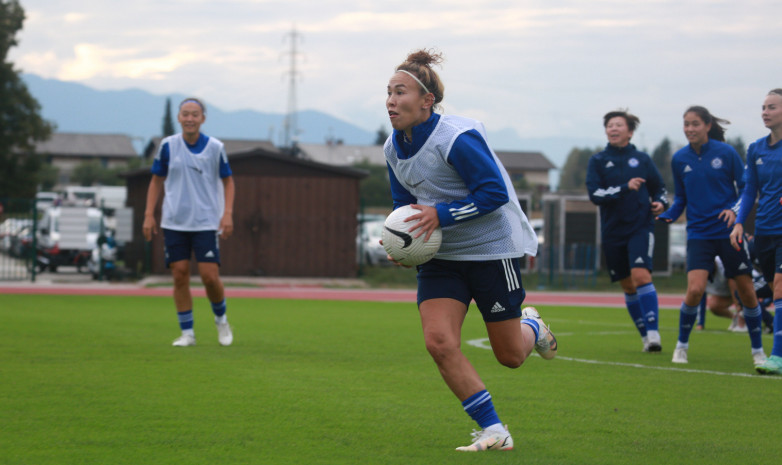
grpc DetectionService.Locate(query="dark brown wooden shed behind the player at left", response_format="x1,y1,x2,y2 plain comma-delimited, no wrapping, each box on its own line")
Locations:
125,148,367,278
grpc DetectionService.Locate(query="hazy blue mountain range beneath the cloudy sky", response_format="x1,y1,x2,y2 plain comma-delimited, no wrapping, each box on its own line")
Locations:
22,74,604,172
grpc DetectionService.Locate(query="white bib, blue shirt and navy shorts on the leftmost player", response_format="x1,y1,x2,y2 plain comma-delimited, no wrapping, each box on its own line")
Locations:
151,134,232,264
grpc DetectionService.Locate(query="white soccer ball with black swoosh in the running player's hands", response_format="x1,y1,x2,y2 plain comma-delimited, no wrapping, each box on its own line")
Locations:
381,205,443,266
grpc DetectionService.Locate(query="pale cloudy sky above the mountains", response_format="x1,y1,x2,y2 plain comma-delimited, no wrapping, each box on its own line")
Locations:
10,0,782,147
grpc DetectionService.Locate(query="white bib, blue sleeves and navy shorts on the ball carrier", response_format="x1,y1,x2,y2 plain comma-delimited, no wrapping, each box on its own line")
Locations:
384,113,538,321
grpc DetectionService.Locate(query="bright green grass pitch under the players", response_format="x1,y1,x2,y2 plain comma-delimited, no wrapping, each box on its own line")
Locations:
0,295,782,465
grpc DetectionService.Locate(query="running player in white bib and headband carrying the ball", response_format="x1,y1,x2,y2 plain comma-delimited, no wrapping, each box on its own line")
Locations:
384,50,557,451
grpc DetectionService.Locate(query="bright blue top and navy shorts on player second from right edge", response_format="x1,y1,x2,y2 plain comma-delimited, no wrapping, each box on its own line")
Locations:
660,139,752,278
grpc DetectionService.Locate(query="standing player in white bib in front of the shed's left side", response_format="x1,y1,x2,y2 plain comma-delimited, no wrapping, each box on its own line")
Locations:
143,98,234,347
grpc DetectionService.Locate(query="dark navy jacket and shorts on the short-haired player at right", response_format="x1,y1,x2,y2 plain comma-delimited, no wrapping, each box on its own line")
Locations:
586,144,668,281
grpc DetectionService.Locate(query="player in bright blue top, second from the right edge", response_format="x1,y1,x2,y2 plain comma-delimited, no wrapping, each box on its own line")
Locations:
659,106,766,365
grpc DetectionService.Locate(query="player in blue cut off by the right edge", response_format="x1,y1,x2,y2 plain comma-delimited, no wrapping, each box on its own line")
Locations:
730,89,782,375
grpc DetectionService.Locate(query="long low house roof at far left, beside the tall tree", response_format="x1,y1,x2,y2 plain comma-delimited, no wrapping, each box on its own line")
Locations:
35,132,138,158
